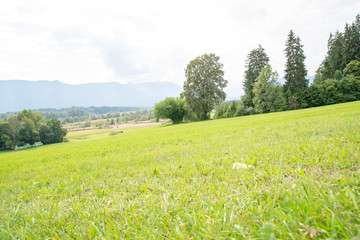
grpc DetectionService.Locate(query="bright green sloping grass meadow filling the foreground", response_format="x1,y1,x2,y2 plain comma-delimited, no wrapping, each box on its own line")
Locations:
0,102,360,239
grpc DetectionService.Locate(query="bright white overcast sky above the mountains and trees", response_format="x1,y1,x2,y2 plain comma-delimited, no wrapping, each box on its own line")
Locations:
0,0,360,95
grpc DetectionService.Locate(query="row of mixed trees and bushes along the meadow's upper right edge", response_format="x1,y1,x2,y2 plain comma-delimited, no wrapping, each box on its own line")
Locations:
154,15,360,123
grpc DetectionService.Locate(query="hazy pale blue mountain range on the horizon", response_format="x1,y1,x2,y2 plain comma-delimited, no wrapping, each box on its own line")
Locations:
0,80,182,113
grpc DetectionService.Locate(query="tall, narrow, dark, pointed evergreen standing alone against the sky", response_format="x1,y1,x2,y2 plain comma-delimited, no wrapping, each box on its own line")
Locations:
284,30,309,108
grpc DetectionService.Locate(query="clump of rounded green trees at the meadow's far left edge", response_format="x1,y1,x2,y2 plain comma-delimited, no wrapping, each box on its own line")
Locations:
0,110,67,151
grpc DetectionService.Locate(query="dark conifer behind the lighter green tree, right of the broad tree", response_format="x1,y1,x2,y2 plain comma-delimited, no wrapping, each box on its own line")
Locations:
243,45,269,107
